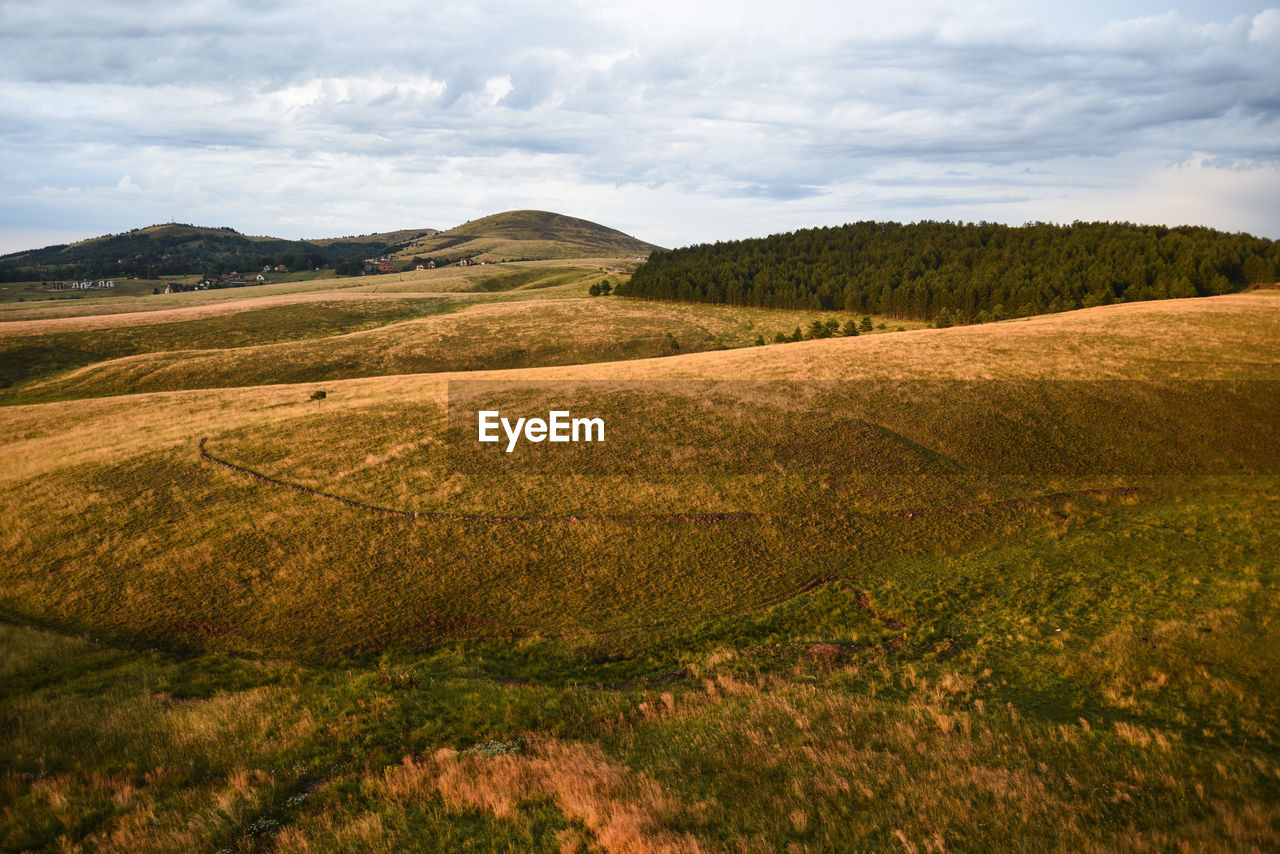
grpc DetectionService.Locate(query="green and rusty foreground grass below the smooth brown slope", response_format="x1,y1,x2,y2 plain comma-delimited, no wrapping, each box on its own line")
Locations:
0,483,1280,850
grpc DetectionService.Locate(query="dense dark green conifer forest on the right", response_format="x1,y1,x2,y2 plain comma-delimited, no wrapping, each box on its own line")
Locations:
617,222,1280,324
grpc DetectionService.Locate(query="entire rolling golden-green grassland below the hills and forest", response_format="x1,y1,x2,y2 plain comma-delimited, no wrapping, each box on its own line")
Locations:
0,259,1280,851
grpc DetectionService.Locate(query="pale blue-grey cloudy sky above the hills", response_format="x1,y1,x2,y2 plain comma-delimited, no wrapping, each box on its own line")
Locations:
0,0,1280,252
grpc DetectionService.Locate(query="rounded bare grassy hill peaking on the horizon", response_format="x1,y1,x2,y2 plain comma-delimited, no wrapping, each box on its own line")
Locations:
396,210,660,262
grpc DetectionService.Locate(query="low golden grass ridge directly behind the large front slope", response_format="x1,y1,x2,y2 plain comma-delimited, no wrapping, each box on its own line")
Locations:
5,298,911,402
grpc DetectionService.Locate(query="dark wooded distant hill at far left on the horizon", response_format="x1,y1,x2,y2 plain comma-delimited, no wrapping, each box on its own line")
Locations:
0,223,436,282
